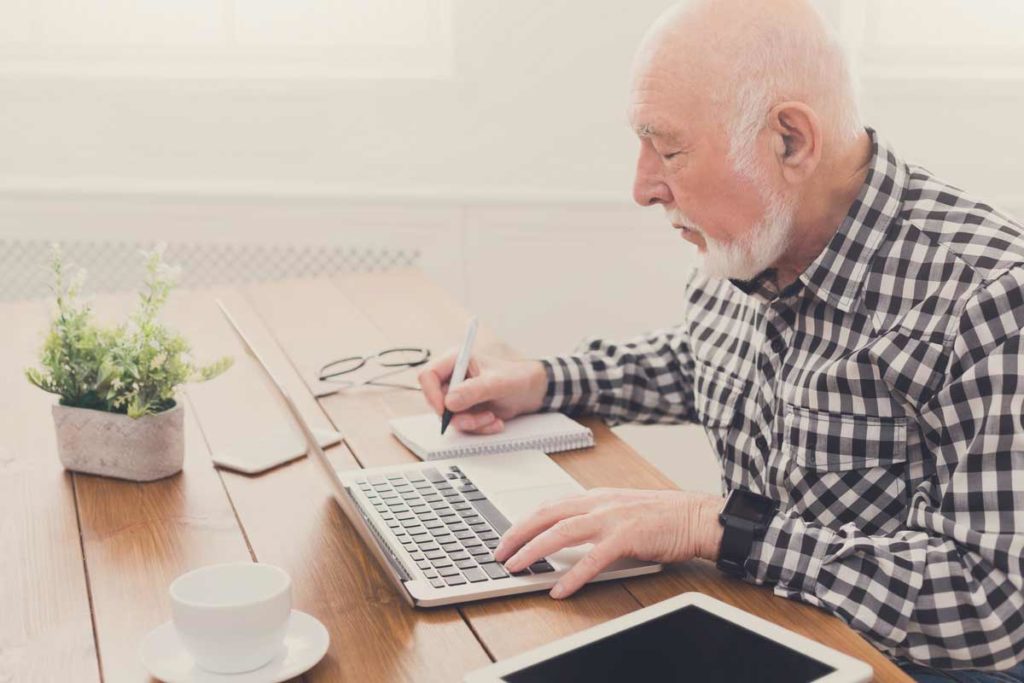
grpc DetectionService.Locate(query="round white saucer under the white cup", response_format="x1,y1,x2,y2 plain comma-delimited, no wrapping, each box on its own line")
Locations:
139,609,331,683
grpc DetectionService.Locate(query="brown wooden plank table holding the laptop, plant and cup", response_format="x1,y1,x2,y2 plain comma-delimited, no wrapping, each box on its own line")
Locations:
0,271,909,683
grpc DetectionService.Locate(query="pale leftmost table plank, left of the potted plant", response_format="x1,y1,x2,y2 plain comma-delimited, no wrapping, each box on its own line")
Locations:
0,302,99,683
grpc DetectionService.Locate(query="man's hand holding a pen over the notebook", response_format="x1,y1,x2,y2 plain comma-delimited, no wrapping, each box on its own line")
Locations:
419,349,548,434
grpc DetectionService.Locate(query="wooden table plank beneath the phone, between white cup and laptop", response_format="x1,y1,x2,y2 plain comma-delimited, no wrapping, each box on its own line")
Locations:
168,288,488,681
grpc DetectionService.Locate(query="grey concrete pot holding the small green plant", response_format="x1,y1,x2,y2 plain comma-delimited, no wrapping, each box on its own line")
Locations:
53,403,185,481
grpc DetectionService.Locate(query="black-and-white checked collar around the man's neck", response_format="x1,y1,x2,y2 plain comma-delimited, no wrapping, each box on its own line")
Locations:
731,128,907,312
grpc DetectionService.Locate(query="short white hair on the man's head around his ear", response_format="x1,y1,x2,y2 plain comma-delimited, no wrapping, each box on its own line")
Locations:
721,1,864,180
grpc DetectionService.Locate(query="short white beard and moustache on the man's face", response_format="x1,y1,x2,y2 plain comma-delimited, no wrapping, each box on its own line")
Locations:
668,188,796,280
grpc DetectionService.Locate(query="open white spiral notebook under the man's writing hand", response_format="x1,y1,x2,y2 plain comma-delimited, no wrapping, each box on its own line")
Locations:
388,413,594,460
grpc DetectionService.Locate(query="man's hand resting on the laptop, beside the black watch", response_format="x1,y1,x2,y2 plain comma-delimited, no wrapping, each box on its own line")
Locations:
495,488,725,598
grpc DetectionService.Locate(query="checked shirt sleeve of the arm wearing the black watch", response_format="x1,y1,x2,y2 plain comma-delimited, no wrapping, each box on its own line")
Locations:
746,268,1024,670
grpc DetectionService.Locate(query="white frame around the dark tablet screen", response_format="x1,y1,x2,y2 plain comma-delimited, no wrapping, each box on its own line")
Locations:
464,593,874,683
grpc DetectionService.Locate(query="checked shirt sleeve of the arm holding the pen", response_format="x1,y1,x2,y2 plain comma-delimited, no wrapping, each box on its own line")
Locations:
541,327,696,424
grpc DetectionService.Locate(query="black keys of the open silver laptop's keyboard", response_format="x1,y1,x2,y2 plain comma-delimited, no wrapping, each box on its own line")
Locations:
354,466,554,588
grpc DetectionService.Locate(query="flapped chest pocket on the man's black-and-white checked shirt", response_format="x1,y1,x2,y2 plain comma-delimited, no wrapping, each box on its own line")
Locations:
781,403,907,533
